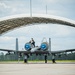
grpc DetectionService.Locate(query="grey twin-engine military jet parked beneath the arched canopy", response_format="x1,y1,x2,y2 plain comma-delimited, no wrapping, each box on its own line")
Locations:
0,38,75,63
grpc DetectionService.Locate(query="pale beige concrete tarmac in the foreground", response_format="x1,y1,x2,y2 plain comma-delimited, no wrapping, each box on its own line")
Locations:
0,64,75,75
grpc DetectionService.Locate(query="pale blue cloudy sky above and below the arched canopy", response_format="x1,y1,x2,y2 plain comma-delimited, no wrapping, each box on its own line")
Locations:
0,0,75,51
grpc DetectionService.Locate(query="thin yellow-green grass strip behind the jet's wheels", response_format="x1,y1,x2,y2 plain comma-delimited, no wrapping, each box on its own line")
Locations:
0,60,75,64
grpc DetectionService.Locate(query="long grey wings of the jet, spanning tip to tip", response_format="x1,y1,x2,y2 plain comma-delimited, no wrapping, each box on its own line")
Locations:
0,49,75,54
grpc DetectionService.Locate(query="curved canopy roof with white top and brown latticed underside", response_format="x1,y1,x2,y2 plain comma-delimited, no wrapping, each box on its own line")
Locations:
0,14,75,34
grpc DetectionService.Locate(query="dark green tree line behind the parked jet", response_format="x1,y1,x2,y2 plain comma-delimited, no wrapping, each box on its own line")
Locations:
0,52,75,61
